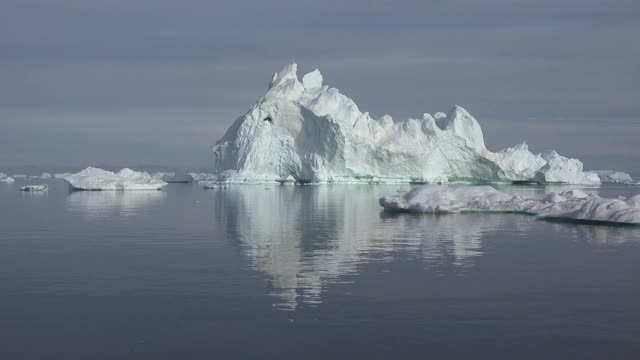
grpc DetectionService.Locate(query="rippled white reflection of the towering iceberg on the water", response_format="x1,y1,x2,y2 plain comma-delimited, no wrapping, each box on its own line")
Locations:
214,186,533,308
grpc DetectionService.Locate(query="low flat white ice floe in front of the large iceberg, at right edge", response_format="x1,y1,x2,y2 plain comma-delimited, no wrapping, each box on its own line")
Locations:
380,185,640,224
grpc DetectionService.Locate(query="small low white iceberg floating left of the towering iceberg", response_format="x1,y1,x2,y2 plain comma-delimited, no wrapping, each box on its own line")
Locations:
64,167,167,190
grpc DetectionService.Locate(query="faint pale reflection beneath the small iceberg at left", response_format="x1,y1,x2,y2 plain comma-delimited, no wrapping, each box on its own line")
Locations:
67,191,167,217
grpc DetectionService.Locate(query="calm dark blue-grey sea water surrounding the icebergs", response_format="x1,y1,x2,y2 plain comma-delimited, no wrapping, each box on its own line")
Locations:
0,181,640,359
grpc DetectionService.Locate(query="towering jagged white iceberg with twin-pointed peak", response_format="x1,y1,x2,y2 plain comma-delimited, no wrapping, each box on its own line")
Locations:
213,64,600,184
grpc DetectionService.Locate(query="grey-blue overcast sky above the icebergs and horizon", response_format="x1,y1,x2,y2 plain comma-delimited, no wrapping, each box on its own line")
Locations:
0,0,640,175
